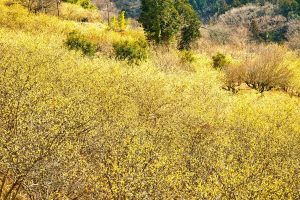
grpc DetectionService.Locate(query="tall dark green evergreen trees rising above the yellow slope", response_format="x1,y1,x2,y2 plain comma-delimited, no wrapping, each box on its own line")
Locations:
139,0,200,49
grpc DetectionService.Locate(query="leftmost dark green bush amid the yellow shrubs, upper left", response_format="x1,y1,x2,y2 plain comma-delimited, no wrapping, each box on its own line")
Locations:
65,31,96,56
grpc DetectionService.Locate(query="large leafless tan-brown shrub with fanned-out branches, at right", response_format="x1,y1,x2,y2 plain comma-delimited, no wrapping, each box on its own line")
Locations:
223,45,292,93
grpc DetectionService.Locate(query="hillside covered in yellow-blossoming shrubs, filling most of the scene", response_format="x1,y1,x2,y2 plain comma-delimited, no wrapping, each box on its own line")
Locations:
0,0,300,199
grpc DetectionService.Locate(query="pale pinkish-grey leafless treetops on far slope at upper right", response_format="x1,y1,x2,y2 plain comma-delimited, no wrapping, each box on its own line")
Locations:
216,3,300,42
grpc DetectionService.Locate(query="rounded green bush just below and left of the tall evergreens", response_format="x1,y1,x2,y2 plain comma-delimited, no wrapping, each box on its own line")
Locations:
113,39,148,64
